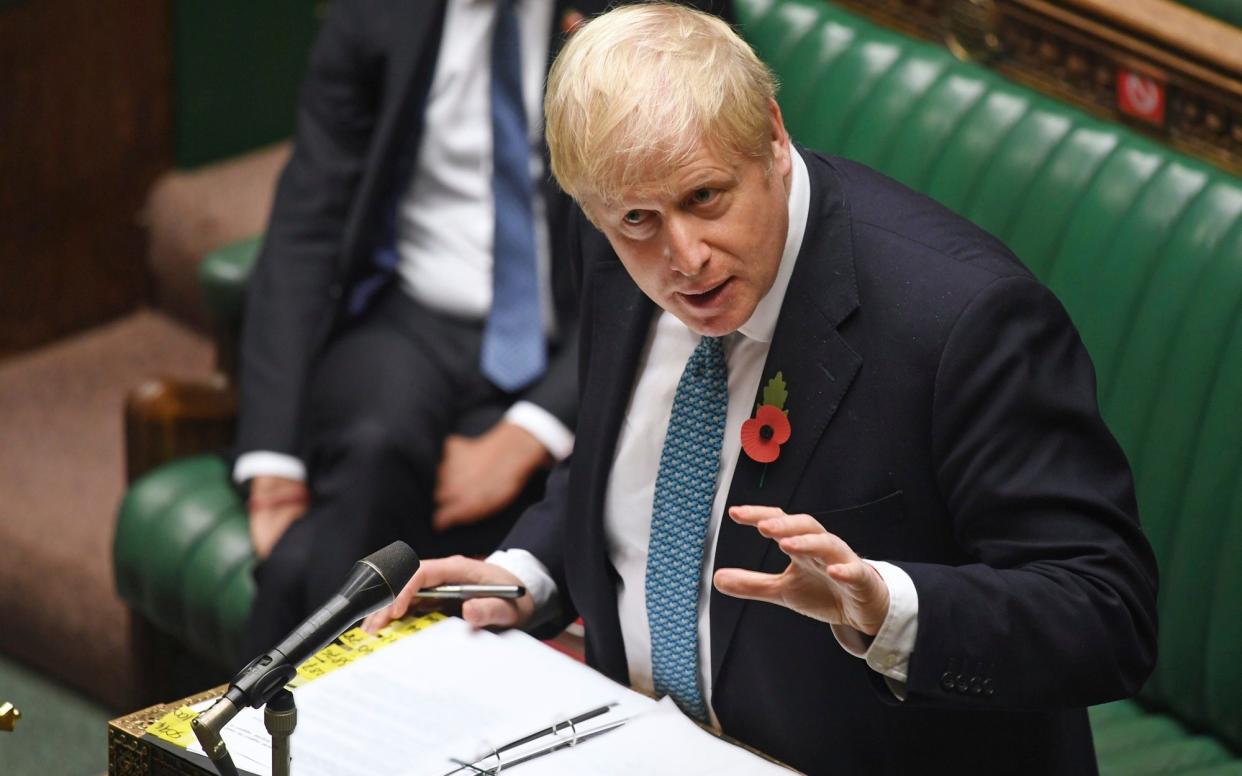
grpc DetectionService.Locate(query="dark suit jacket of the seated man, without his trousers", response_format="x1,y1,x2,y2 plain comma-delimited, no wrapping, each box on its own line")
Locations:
238,0,591,471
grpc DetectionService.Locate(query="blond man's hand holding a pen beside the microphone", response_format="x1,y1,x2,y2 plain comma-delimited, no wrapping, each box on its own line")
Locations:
363,555,535,633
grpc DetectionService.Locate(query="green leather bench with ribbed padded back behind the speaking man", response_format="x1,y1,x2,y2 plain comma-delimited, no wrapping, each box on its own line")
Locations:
116,0,1242,775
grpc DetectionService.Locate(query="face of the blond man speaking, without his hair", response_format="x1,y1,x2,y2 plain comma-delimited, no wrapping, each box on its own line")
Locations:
584,106,790,336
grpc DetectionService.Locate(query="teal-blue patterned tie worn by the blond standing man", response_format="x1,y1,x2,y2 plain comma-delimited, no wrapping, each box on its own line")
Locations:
646,336,729,723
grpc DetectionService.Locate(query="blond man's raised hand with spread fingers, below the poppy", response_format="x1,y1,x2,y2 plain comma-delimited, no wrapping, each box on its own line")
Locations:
713,507,888,636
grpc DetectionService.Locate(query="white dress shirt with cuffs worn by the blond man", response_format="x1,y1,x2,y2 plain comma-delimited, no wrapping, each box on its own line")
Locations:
488,151,918,723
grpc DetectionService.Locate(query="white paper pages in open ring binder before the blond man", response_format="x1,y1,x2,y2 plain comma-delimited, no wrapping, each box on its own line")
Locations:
190,618,787,776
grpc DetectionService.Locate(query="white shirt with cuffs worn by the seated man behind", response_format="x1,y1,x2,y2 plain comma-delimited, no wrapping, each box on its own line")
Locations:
233,0,574,482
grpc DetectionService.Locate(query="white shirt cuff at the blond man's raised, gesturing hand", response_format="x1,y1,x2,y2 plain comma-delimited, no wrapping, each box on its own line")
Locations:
832,560,919,700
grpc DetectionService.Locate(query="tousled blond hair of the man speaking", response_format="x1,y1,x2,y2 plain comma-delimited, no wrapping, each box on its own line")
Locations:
544,2,776,205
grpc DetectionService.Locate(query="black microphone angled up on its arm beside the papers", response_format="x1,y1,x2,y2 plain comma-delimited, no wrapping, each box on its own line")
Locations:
191,541,419,774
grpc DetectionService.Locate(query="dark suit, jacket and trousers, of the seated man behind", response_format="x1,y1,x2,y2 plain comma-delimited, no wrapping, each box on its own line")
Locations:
237,0,732,653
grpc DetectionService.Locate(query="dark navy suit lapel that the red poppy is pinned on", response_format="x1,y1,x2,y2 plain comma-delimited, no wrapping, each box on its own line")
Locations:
710,154,862,687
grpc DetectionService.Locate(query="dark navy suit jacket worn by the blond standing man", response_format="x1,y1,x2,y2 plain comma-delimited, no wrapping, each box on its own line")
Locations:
504,146,1155,774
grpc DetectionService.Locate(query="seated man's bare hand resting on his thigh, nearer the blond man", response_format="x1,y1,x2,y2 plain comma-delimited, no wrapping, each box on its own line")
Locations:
431,421,551,530
